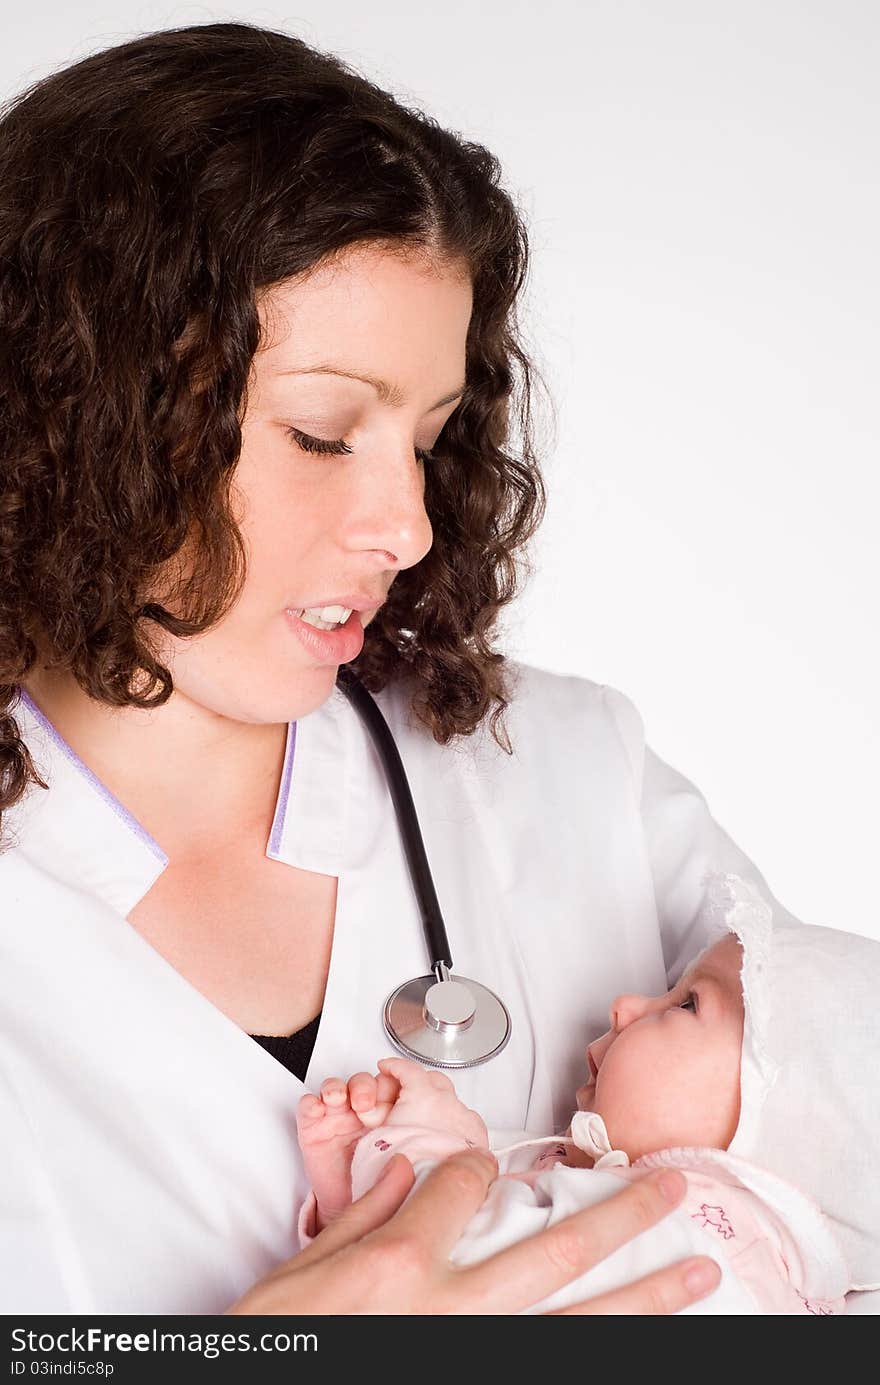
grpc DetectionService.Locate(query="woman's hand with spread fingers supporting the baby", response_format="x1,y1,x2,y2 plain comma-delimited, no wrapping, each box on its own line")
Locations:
227,1150,721,1316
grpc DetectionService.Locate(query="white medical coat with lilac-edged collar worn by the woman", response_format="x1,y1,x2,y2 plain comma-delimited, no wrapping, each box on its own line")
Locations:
0,666,870,1314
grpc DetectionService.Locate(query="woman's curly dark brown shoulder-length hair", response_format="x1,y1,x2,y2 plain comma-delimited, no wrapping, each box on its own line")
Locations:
0,24,546,842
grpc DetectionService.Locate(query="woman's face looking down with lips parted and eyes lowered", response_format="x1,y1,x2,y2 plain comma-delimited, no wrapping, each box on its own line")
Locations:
161,247,473,723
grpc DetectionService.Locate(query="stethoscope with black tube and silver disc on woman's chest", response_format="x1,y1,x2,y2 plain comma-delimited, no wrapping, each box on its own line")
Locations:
337,663,510,1068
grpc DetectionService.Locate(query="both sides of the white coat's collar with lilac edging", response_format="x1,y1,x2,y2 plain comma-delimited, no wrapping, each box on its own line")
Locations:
9,688,356,917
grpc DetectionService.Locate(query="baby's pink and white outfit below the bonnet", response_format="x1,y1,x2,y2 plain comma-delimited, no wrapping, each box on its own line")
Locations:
299,1094,850,1316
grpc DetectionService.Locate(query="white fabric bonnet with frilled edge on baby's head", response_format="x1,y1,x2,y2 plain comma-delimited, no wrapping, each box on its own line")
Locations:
692,874,880,1288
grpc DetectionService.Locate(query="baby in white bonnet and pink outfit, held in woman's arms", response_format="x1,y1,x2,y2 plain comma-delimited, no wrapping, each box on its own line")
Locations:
297,875,880,1316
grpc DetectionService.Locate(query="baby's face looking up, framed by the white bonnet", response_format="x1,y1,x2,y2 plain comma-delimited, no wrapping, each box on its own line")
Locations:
578,933,743,1159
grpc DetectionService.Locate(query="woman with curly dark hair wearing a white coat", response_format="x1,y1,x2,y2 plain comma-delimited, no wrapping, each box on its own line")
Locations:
0,24,803,1313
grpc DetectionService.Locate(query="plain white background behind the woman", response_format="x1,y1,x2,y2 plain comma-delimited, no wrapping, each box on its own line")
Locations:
6,0,880,938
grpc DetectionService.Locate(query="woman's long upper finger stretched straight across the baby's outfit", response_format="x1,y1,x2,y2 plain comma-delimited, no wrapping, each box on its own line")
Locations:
454,1169,695,1313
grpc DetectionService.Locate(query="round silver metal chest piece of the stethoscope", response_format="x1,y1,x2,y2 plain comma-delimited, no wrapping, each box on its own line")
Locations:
382,968,510,1068
